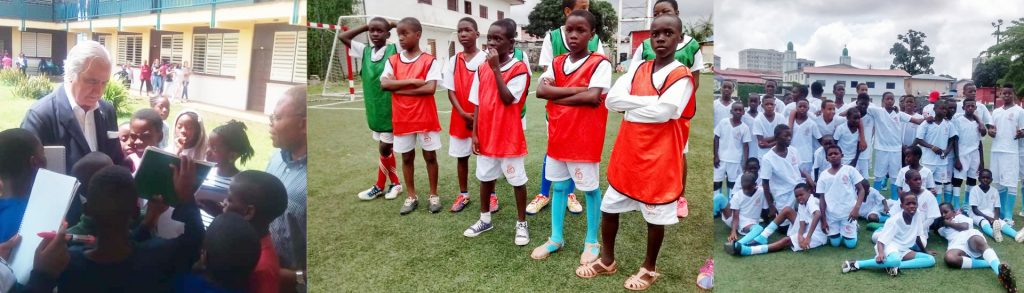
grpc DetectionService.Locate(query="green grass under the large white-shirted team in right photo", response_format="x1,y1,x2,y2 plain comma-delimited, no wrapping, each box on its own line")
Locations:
713,134,1024,292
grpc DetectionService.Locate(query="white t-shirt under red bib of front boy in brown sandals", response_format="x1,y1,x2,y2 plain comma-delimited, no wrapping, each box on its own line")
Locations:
604,60,693,123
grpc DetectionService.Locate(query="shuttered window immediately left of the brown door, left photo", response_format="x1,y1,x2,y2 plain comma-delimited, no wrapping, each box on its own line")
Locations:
193,33,239,76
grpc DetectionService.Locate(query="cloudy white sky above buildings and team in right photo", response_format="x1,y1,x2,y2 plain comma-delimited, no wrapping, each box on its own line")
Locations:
714,0,1024,78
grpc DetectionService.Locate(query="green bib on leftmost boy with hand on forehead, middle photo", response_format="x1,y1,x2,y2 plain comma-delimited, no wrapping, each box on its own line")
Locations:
359,44,398,132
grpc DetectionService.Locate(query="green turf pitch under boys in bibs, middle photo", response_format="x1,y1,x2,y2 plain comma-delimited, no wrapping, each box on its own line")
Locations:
308,73,712,292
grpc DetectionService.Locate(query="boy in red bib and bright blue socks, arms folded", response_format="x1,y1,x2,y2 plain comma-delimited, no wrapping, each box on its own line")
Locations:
530,10,611,264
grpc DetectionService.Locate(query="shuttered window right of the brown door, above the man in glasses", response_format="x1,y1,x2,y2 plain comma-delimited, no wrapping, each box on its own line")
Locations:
270,31,306,83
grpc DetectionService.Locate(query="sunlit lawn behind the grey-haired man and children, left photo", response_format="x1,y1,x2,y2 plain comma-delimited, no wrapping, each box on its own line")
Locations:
0,84,273,171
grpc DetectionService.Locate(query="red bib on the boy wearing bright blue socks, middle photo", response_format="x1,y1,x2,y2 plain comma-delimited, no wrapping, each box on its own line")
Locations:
546,53,608,163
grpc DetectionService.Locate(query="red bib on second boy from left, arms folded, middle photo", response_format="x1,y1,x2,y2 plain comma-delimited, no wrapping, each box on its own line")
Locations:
388,53,441,135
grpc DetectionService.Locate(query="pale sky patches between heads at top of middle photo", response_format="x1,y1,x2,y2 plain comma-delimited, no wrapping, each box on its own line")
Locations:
511,0,714,34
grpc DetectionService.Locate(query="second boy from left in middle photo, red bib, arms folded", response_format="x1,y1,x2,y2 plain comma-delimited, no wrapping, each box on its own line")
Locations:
380,17,441,215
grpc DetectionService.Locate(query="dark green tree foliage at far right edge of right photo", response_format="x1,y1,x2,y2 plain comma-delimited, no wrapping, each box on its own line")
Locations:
976,17,1024,95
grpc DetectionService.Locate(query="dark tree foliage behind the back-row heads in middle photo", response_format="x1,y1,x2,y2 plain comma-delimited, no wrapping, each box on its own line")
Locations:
526,0,618,44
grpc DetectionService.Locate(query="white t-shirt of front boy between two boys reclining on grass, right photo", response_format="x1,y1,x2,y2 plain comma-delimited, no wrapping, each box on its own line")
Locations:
815,165,864,218
